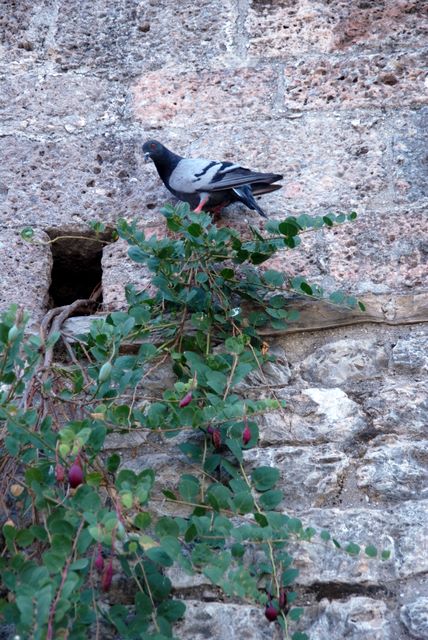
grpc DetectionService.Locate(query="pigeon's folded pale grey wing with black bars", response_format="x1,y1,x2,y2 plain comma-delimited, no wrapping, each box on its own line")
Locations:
169,158,282,193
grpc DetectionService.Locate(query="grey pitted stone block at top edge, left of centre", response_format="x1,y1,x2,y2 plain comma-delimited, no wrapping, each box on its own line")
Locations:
50,0,236,80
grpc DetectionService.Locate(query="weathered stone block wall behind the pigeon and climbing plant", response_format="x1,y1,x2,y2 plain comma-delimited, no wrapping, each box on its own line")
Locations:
0,0,428,640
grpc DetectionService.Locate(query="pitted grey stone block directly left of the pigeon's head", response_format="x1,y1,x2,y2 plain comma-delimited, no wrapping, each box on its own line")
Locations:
0,132,162,230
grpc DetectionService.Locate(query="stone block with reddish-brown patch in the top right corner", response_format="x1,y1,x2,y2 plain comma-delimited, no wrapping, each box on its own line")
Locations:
245,0,427,59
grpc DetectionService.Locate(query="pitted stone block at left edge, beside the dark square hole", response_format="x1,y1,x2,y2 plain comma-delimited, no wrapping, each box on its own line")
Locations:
0,229,52,327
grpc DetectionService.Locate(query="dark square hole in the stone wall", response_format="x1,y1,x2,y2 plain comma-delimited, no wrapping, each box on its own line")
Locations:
46,229,113,309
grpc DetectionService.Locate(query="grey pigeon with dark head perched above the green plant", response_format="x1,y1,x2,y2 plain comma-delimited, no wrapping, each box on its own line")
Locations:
143,140,282,218
